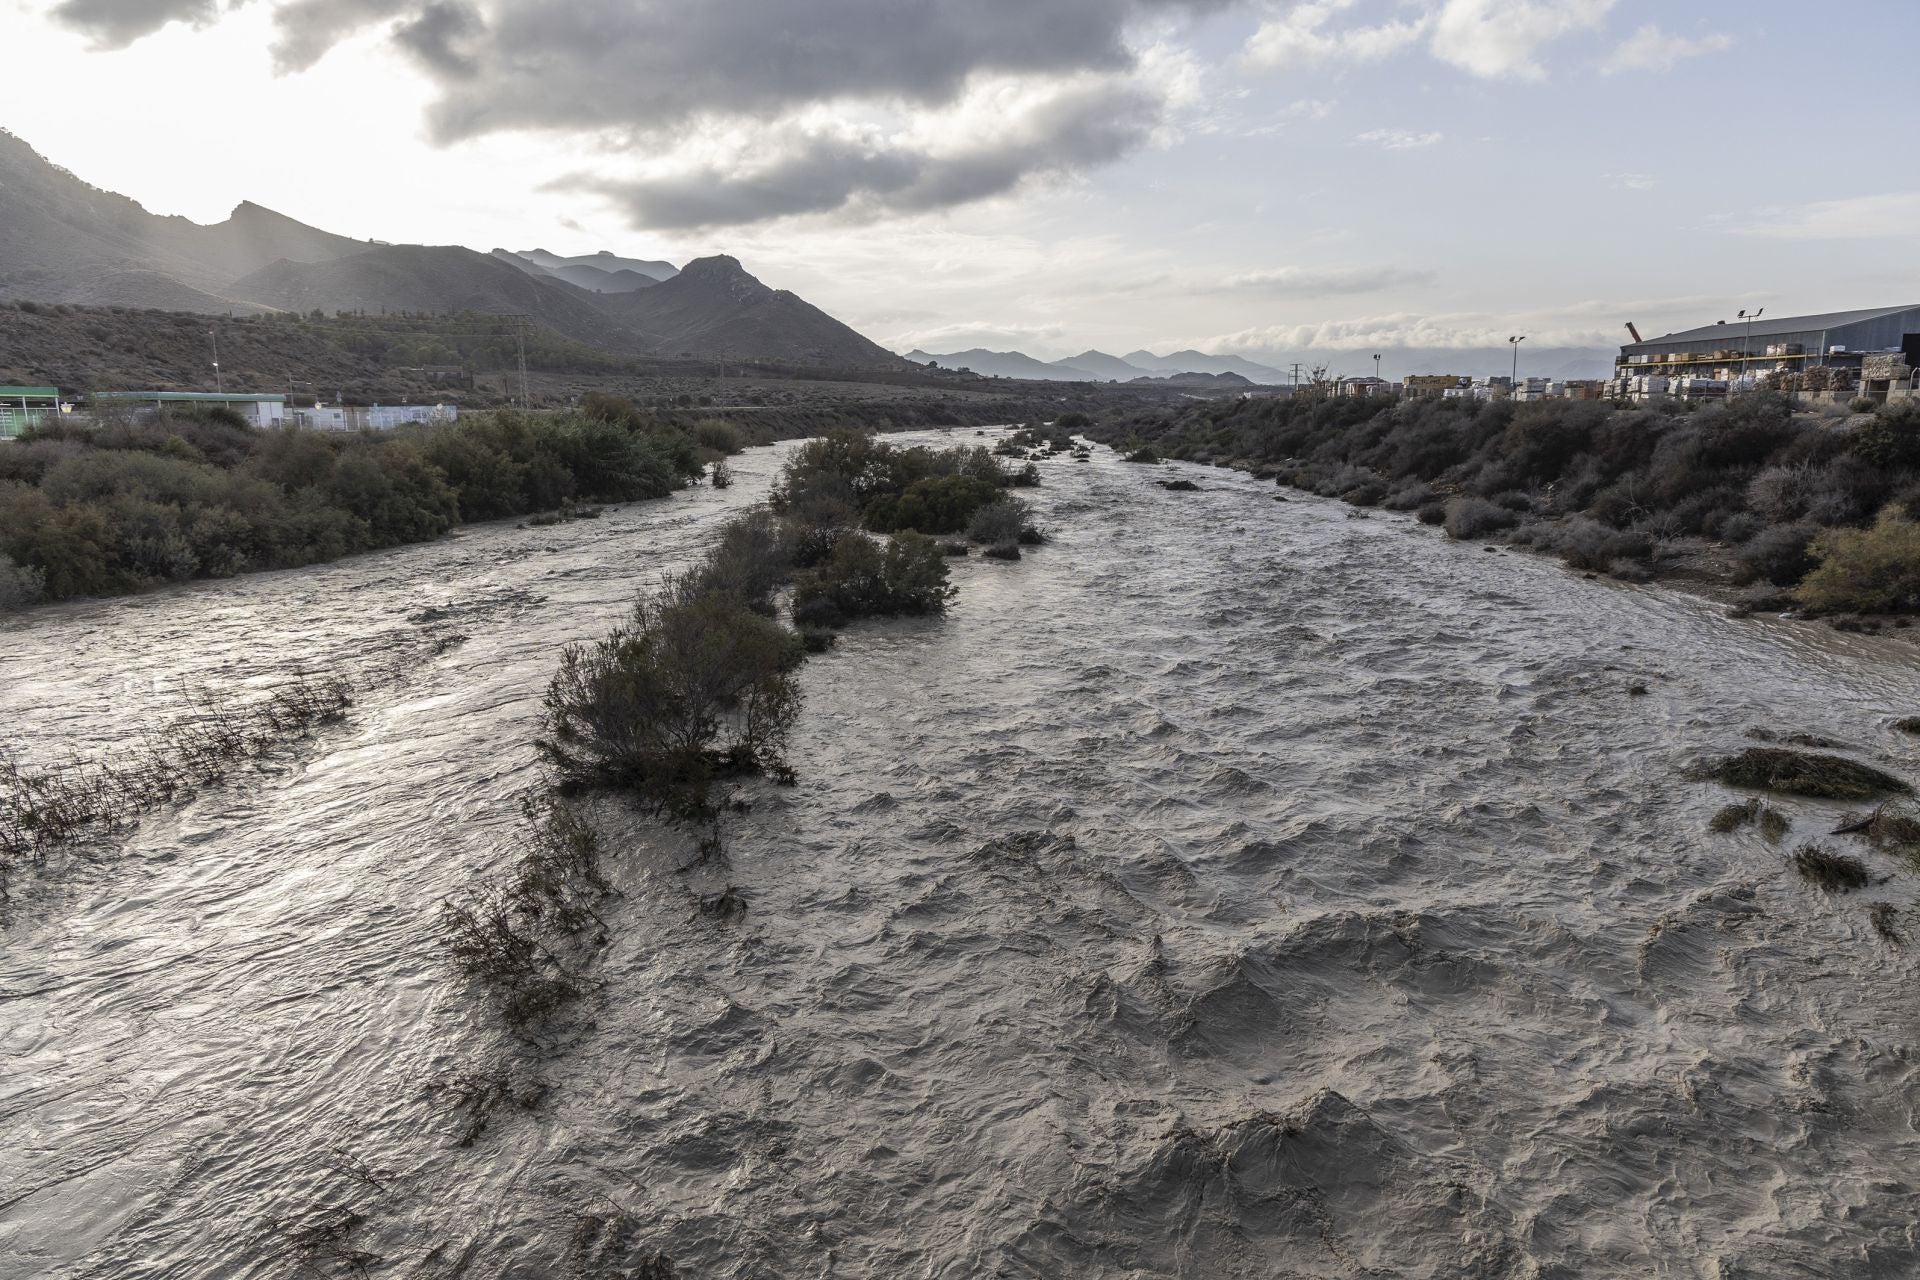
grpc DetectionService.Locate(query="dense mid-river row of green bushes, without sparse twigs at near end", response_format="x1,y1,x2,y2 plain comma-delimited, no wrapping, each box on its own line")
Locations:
538,432,1029,832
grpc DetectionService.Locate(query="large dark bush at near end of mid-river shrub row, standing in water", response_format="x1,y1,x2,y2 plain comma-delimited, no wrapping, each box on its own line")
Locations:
536,566,802,821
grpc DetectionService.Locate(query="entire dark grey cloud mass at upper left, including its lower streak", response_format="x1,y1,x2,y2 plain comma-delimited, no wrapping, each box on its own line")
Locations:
41,0,1238,226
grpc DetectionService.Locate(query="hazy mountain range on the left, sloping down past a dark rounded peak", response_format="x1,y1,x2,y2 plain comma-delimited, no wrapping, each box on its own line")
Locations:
0,132,906,368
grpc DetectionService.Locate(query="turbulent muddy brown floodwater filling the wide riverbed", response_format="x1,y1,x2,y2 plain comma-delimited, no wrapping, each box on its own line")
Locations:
0,434,1920,1280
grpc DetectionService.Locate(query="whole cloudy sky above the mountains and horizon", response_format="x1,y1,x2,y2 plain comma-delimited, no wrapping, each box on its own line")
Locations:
0,0,1920,363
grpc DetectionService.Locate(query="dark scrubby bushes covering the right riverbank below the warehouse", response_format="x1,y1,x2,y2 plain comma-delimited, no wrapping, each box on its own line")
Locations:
1089,391,1920,612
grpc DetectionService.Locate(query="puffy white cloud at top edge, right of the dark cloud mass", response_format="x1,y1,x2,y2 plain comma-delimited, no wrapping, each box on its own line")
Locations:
1246,0,1619,81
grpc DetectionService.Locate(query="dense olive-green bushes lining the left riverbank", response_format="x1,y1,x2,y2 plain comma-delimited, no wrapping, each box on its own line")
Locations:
0,397,745,608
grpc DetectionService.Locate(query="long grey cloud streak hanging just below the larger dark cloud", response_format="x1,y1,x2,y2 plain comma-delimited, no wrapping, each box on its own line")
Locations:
557,83,1160,228
